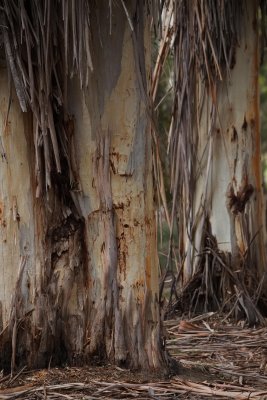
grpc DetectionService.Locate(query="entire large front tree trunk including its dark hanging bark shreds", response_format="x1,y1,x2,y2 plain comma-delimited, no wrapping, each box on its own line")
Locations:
0,0,166,370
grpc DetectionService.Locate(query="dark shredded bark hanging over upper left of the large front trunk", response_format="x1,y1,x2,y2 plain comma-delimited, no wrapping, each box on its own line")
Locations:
0,0,164,196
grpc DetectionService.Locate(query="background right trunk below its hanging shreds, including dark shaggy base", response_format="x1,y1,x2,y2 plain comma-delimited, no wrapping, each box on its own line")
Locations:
175,1,266,320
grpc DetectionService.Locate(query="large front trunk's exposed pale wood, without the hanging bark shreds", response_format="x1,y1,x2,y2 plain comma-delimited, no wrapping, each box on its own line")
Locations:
0,1,164,369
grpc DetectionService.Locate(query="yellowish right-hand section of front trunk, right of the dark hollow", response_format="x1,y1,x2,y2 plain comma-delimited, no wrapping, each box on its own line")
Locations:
66,2,164,369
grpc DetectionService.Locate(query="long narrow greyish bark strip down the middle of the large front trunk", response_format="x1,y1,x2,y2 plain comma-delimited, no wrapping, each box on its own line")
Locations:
87,132,127,363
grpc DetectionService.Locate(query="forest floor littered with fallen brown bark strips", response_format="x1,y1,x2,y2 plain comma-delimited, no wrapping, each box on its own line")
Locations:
0,313,267,400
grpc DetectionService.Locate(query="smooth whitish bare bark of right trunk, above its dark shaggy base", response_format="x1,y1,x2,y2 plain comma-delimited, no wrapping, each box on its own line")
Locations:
184,2,265,280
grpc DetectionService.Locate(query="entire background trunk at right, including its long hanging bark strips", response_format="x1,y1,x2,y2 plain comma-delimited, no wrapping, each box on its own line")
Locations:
169,0,266,323
